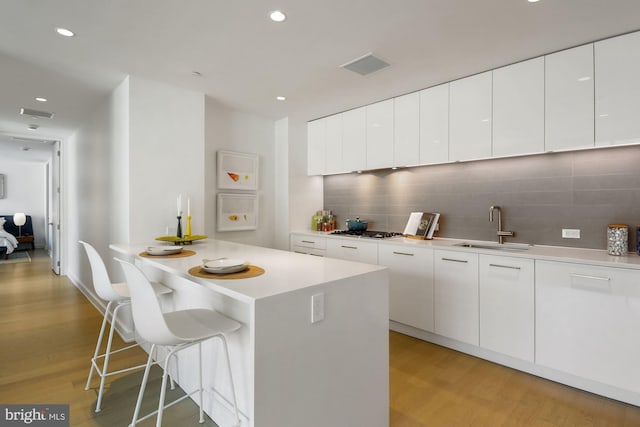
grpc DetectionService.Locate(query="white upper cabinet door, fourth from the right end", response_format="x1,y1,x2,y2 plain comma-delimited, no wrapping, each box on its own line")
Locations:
449,71,492,161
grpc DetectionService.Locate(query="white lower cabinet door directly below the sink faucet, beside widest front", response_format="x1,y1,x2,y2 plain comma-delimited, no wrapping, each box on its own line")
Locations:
479,255,535,363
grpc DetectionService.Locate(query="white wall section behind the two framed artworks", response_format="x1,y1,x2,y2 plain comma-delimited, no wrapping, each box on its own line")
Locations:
205,97,276,247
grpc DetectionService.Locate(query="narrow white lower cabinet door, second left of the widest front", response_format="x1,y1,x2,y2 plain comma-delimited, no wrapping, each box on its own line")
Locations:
434,250,479,345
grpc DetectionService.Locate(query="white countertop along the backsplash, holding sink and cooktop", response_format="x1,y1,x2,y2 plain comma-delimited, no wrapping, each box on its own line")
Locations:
295,231,640,270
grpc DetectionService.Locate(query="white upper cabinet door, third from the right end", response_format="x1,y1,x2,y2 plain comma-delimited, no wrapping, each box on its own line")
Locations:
492,58,544,157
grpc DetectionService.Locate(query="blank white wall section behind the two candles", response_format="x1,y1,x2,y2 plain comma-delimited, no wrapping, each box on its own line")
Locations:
129,77,205,243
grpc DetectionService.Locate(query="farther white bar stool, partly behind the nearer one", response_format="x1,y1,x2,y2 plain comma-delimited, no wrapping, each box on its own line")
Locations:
80,241,172,412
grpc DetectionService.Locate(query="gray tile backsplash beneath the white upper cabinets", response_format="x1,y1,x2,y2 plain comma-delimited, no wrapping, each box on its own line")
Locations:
324,146,640,251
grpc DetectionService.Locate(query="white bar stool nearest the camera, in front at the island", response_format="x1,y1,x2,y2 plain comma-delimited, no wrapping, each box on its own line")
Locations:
116,258,242,427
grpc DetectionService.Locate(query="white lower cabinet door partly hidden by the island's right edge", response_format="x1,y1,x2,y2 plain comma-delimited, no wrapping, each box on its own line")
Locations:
378,243,434,332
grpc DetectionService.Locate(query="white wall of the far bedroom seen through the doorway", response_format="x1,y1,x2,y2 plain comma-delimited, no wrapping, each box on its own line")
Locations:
0,158,47,248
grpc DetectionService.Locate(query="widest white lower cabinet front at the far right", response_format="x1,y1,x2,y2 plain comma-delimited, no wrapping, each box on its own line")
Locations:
535,261,640,393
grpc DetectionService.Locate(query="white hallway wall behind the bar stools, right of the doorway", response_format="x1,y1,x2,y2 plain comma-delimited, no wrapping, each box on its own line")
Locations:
62,79,129,290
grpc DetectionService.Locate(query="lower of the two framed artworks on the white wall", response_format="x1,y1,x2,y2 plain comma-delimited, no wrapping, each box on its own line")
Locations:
217,193,258,231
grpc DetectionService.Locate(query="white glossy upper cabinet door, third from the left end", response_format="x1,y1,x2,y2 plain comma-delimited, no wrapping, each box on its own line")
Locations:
342,107,367,172
